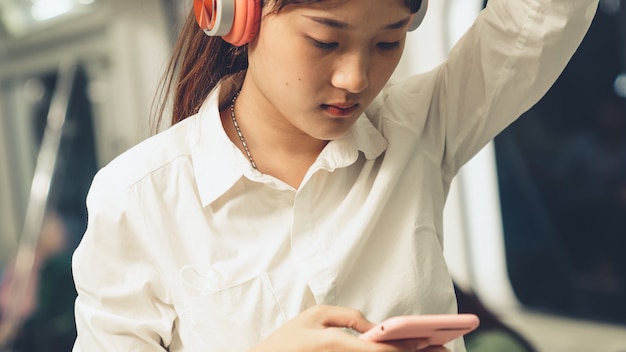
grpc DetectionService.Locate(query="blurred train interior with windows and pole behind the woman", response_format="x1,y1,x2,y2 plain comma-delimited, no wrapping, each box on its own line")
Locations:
0,0,626,352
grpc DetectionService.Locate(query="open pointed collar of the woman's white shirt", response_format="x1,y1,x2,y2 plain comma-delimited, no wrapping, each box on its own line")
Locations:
192,87,388,206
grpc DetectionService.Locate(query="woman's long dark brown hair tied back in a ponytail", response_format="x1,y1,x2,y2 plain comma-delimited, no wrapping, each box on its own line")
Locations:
154,0,422,131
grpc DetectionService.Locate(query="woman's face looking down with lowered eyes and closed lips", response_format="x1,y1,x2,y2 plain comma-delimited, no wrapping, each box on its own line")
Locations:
244,0,411,140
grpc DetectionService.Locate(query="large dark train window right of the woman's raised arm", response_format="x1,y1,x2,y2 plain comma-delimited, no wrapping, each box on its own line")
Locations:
494,0,626,324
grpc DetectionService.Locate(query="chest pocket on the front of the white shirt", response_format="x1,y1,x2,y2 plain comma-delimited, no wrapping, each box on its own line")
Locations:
175,267,287,351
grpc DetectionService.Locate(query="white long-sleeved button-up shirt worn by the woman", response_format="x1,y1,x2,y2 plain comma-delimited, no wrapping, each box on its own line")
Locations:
73,0,597,352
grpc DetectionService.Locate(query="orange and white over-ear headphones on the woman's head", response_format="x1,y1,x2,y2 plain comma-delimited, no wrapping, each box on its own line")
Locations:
193,0,428,46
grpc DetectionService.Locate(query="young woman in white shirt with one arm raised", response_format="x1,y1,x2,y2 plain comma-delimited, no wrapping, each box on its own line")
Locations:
73,0,597,352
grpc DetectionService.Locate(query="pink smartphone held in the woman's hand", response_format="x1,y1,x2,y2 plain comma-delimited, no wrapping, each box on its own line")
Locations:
360,314,480,346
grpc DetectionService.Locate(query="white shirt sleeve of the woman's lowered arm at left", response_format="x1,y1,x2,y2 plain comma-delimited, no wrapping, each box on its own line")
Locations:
72,169,175,352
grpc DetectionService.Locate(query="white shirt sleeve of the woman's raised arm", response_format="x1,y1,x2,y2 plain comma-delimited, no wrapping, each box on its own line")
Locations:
385,0,598,176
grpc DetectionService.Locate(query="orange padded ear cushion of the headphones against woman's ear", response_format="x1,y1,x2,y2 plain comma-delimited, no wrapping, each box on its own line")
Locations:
222,0,261,46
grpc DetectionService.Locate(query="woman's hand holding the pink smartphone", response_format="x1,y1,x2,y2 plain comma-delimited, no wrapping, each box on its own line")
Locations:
249,305,448,352
